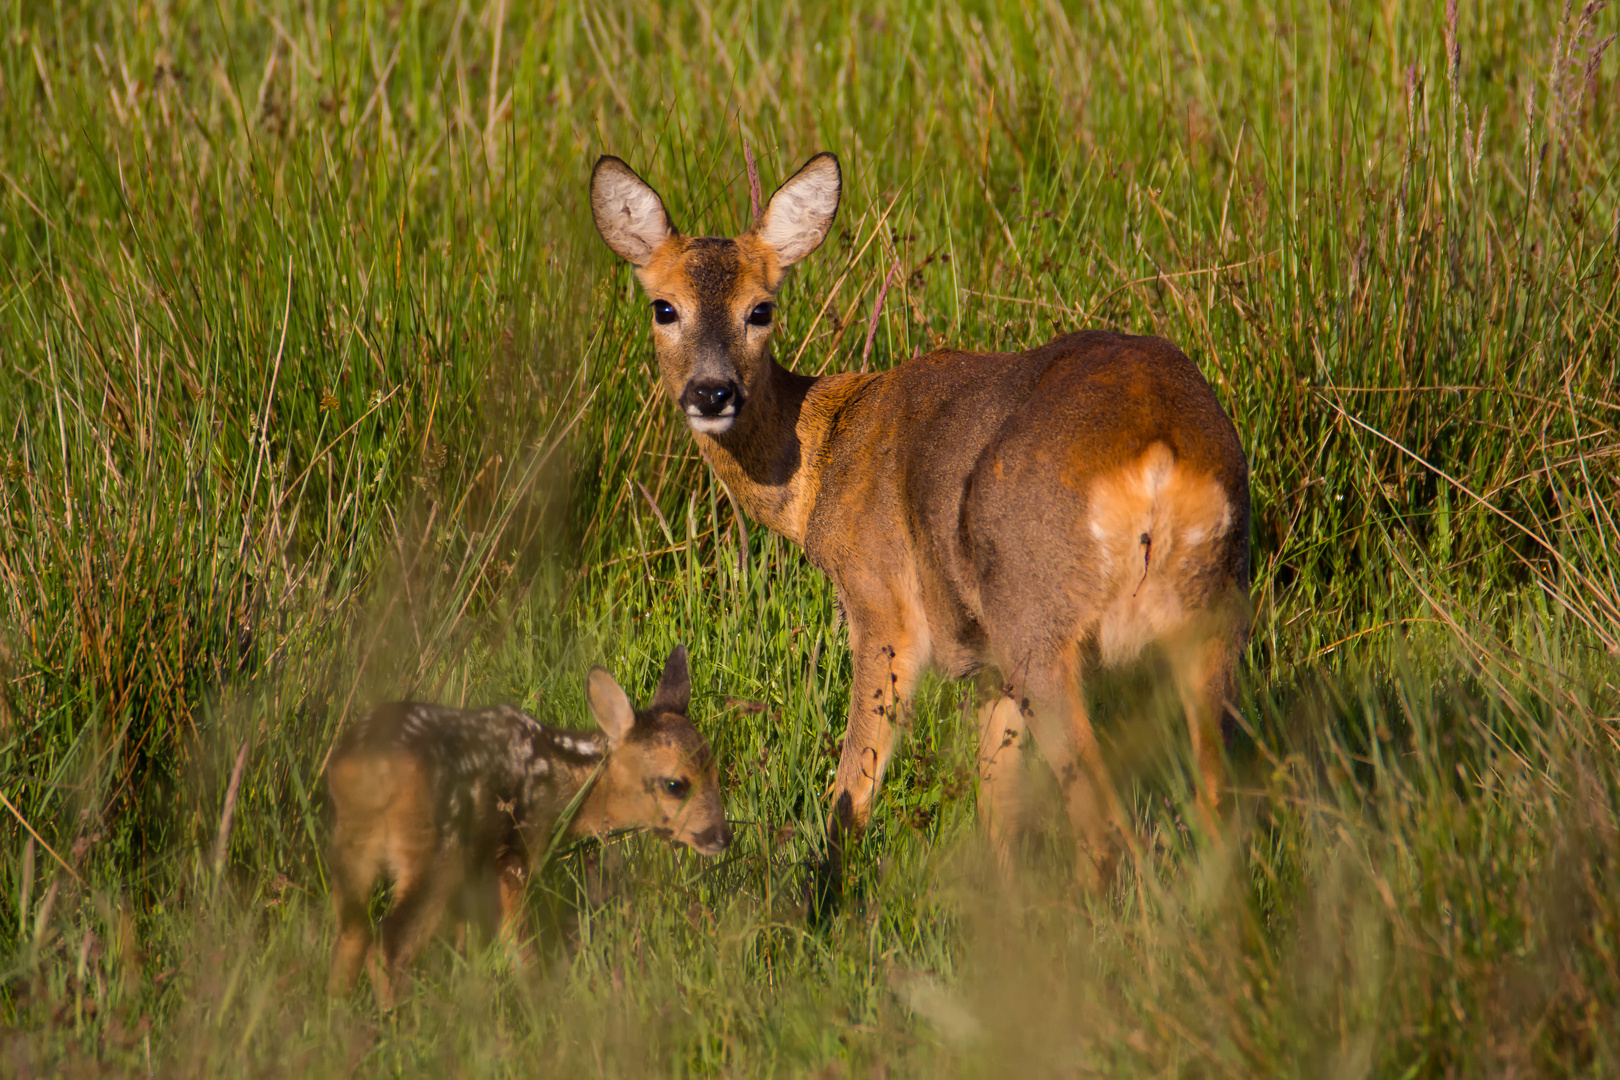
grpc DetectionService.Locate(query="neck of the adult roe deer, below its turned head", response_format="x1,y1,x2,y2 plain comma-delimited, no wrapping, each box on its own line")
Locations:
693,359,872,544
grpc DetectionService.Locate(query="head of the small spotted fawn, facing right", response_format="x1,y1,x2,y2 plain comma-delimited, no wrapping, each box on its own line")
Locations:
582,644,731,855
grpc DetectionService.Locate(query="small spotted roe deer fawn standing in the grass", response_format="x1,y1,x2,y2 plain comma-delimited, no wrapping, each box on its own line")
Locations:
327,646,731,1009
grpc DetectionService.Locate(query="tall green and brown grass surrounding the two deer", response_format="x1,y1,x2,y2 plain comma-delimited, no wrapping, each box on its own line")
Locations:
0,0,1620,1077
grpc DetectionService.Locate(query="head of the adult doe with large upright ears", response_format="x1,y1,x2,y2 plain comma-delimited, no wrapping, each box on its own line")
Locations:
591,154,842,436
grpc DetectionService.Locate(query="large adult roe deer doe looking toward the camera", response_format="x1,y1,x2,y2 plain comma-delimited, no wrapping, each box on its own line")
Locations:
591,154,1249,887
